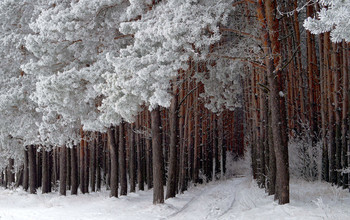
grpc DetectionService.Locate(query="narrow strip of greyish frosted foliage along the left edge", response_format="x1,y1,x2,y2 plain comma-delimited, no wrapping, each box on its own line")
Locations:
0,0,41,169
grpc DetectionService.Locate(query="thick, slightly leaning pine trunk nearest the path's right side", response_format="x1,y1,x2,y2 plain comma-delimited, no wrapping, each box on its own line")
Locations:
258,0,289,204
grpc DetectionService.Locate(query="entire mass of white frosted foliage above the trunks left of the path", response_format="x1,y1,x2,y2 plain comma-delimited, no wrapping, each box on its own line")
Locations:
0,0,252,170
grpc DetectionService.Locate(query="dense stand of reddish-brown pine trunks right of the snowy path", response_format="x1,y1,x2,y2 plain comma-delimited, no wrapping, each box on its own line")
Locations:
246,0,350,204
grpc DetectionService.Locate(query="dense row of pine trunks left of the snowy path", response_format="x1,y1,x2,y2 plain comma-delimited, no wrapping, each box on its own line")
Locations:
1,90,244,203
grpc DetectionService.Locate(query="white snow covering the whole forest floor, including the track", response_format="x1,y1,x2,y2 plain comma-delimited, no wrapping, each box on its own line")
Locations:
0,177,350,220
